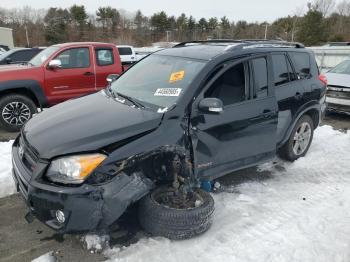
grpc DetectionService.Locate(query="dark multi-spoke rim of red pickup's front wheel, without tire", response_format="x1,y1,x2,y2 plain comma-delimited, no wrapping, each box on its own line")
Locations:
1,102,31,126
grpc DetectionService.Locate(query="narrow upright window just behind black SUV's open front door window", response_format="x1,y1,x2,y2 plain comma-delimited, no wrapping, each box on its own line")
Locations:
252,57,268,98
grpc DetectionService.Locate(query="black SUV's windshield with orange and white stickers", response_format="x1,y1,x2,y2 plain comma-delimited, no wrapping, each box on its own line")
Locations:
111,54,205,108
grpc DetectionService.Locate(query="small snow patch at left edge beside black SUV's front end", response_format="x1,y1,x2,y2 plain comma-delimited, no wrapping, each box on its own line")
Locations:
0,141,16,197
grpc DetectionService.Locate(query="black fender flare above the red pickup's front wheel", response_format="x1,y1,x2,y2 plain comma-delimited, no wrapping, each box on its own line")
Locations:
0,79,48,108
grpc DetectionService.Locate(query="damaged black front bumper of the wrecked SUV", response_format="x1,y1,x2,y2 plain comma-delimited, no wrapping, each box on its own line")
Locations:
12,139,153,233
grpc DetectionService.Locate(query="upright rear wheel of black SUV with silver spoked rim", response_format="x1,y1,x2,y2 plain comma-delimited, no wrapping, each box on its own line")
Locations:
278,115,314,161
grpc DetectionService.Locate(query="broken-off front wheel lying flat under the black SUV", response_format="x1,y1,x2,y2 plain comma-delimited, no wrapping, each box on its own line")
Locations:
139,187,214,240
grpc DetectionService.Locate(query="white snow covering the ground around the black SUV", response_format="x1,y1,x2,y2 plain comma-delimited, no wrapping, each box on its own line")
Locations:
0,126,350,262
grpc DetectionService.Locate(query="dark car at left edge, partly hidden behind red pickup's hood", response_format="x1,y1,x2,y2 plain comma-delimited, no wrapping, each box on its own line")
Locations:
0,47,44,65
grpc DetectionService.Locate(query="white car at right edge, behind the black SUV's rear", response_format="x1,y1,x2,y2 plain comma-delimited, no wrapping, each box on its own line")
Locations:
325,59,350,114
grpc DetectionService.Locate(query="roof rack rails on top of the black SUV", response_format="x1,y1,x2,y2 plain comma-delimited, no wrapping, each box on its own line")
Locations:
173,39,305,49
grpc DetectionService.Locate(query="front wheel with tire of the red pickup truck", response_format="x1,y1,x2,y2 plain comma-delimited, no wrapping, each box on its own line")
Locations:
0,94,37,132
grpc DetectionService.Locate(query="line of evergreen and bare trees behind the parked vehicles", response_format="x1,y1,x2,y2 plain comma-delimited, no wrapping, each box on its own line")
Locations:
0,0,350,46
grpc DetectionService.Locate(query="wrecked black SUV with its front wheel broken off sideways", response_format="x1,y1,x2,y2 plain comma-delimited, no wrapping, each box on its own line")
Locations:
12,40,326,239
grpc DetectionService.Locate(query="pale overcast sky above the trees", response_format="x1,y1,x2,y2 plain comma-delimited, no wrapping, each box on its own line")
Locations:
0,0,338,22
